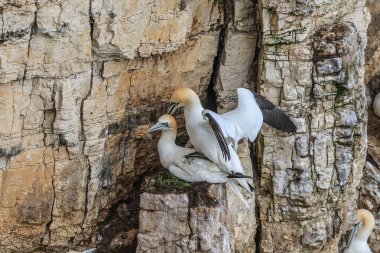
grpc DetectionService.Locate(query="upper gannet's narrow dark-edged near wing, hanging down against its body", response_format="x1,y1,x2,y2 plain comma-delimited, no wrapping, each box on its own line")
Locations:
202,110,231,161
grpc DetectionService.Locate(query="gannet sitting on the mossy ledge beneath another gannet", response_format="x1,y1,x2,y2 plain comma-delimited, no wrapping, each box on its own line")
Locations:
148,114,255,209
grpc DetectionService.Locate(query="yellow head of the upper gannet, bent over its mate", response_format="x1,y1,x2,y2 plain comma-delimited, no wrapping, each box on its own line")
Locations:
168,88,200,114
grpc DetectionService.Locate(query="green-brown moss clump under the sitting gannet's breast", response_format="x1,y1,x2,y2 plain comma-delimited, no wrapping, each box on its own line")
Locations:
154,170,191,191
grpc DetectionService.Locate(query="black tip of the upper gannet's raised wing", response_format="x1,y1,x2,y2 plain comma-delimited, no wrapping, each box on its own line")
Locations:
252,92,297,133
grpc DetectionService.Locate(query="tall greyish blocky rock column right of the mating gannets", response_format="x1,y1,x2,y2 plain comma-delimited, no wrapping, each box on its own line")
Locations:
257,0,369,252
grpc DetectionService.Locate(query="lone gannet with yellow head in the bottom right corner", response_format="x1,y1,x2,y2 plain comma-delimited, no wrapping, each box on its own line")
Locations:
344,209,375,253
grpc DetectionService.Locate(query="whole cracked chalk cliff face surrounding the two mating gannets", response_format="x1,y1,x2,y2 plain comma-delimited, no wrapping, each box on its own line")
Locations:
0,0,376,252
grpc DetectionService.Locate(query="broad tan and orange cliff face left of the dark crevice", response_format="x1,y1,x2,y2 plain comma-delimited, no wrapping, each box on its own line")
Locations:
0,0,224,252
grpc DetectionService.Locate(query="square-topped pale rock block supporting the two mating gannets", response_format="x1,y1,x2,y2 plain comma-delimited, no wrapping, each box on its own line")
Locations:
137,185,234,252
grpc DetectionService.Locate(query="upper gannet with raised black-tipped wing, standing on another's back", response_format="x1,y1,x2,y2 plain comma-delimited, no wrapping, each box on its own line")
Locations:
168,88,296,188
